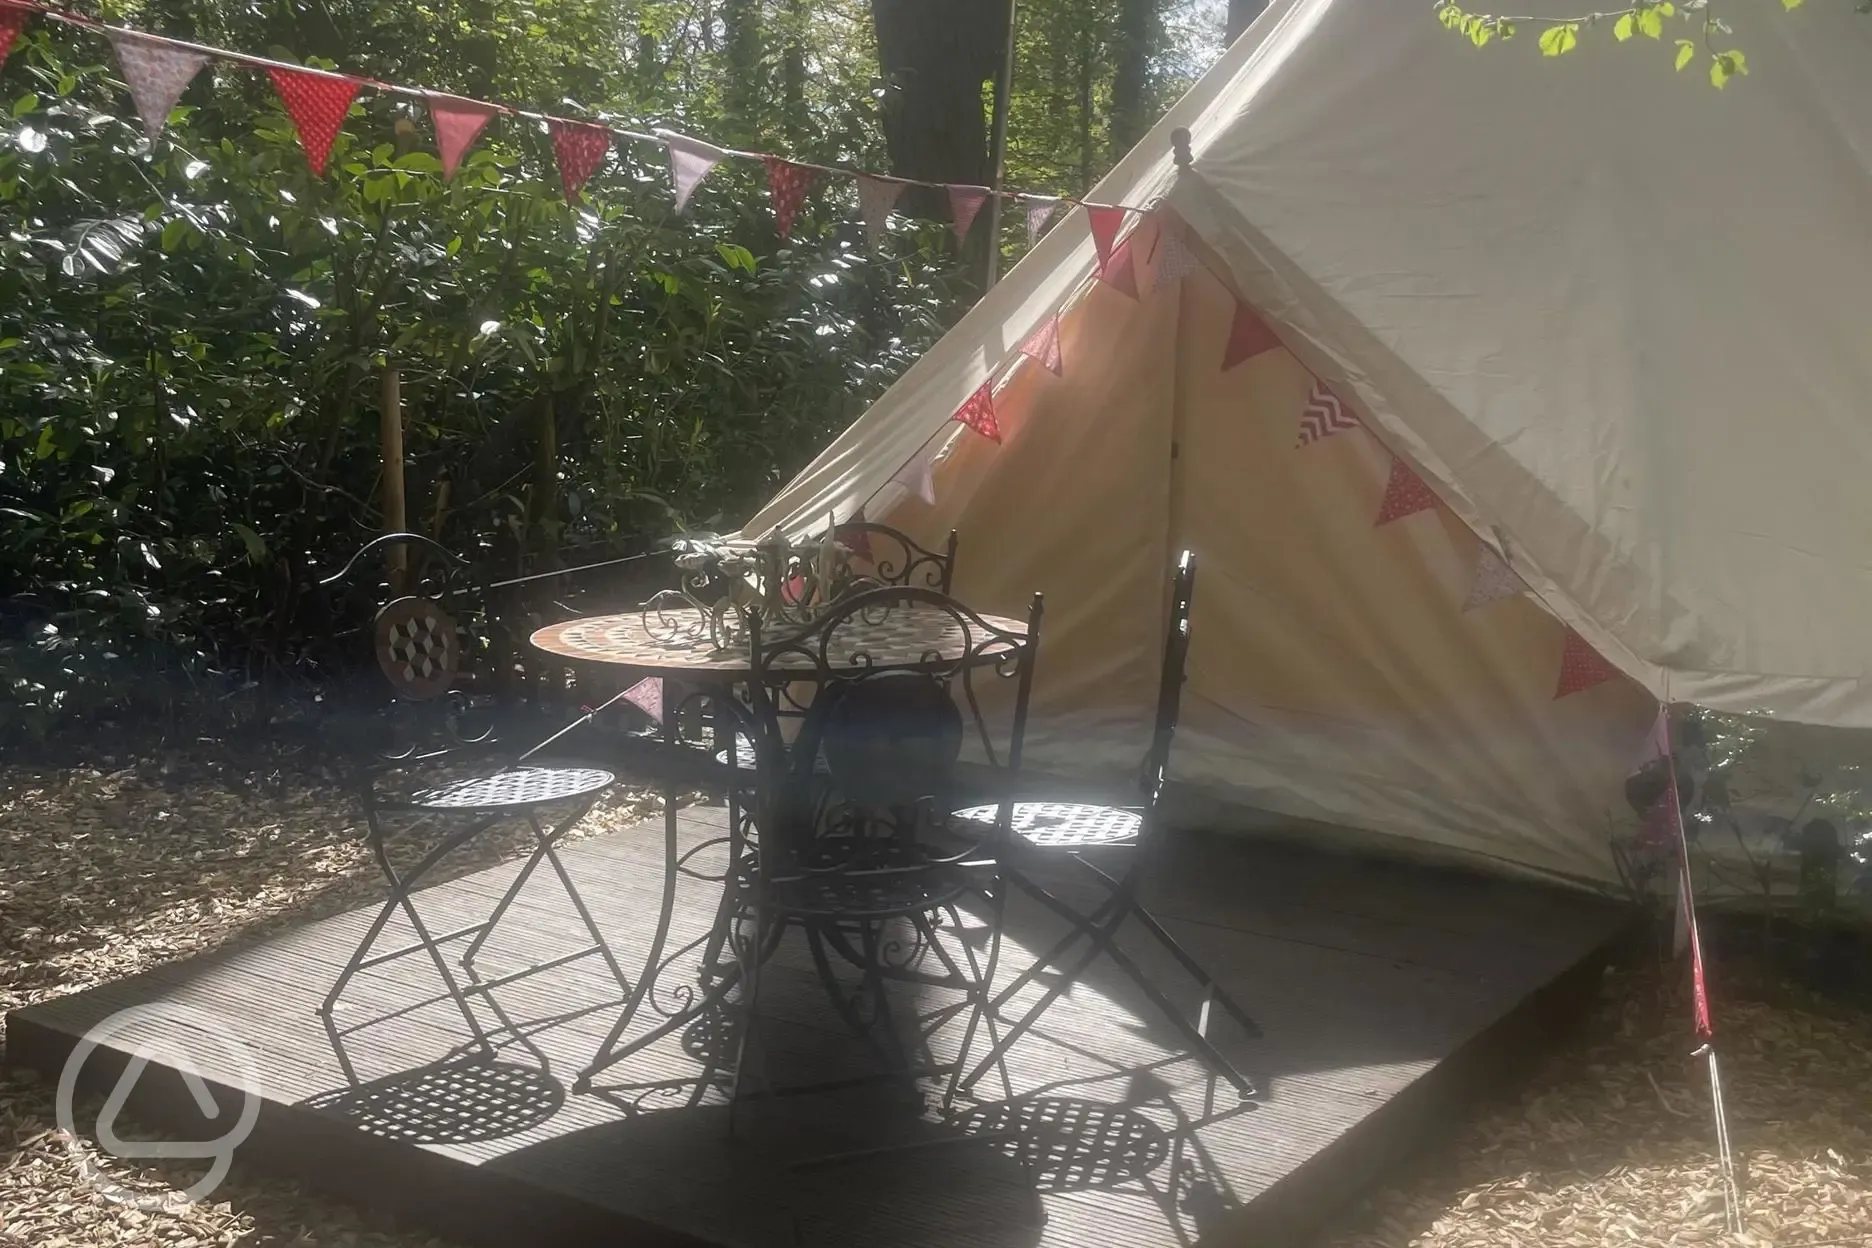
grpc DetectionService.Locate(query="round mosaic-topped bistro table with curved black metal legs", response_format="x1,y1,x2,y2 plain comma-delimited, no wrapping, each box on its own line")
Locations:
532,604,1026,1100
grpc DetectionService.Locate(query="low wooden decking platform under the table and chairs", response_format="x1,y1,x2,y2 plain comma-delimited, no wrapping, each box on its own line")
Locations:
7,808,1623,1248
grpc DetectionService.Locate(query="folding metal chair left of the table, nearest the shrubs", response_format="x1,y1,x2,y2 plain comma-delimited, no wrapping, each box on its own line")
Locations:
318,533,629,1070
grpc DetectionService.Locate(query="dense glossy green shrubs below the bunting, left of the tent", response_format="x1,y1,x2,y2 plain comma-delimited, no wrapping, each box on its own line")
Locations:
0,17,958,737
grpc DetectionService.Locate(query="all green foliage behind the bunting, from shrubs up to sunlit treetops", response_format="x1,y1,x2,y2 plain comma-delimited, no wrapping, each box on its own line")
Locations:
0,0,1221,741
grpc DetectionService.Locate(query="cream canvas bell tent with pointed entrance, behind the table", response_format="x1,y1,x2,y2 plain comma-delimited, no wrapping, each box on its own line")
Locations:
726,0,1872,879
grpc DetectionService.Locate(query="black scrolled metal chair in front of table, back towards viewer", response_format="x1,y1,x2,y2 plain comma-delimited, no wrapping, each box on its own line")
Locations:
711,586,1041,1115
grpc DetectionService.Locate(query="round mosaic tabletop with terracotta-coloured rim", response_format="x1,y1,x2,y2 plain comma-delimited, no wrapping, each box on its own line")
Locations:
532,604,1028,675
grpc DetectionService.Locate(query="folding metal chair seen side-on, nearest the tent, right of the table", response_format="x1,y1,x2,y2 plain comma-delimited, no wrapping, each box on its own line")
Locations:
955,550,1260,1098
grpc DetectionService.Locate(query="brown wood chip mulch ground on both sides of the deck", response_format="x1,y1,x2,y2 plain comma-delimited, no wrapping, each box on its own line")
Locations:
0,755,1872,1248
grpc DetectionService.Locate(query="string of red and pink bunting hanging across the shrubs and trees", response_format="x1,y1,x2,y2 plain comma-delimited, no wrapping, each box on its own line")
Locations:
0,0,1142,219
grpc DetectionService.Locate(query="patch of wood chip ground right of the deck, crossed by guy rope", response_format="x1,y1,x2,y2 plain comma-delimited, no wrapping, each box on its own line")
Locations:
1329,969,1872,1248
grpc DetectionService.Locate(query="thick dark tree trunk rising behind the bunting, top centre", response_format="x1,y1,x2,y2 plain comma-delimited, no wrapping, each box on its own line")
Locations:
870,0,1007,219
